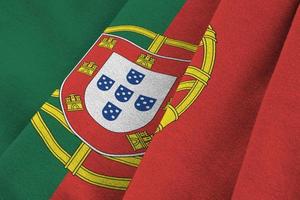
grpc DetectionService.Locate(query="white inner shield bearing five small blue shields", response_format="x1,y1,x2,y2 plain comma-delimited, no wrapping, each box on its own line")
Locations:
85,53,176,133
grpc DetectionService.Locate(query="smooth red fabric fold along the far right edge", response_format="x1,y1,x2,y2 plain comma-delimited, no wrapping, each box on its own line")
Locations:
232,5,300,199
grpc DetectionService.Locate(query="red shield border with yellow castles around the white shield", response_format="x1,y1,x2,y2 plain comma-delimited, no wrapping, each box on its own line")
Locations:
60,34,189,156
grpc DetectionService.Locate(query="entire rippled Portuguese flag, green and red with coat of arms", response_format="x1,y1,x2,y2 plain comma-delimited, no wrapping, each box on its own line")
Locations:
0,0,300,200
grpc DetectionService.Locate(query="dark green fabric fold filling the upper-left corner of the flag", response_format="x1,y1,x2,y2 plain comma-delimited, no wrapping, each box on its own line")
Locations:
0,0,127,155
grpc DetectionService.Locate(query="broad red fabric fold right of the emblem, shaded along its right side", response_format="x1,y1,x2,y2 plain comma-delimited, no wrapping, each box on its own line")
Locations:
124,1,298,199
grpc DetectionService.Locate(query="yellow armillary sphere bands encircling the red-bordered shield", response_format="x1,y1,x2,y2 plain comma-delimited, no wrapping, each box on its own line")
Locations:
31,25,216,190
